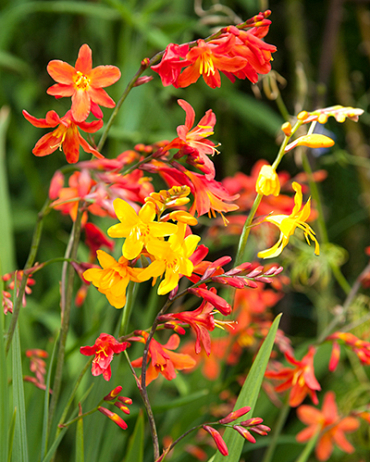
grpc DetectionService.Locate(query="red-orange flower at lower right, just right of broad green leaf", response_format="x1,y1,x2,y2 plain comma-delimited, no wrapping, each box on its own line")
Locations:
265,347,321,407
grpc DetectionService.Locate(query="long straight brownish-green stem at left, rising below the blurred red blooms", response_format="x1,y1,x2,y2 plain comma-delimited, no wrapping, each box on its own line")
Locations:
49,203,83,430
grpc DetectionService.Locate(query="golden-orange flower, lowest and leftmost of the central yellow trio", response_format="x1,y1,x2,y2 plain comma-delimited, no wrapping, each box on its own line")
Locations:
83,250,142,308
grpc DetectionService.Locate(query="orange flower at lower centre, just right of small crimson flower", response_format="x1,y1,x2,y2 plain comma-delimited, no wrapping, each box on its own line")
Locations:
130,331,196,385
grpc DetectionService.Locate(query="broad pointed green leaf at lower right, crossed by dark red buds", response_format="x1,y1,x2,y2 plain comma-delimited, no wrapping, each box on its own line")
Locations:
212,314,281,462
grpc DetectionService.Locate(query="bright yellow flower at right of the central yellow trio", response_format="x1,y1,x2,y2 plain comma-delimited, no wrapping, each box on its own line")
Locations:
139,223,200,295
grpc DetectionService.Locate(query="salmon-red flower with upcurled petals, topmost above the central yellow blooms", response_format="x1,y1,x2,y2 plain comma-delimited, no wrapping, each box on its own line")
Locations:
164,99,218,178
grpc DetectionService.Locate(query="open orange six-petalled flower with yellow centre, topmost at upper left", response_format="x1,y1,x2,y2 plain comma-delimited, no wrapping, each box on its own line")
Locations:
47,44,121,122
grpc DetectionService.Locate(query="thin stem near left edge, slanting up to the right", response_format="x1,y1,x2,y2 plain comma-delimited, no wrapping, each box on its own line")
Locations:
5,198,50,353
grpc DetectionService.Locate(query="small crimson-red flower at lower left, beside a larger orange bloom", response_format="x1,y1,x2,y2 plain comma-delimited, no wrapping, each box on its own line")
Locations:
80,334,130,381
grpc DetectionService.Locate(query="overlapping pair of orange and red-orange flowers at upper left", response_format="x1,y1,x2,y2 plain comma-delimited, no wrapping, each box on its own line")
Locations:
23,44,121,163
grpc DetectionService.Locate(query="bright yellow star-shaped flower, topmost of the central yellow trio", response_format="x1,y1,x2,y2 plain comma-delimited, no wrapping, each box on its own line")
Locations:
108,199,177,260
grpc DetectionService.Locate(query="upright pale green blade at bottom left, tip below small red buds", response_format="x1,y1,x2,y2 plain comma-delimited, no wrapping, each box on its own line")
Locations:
12,324,28,462
